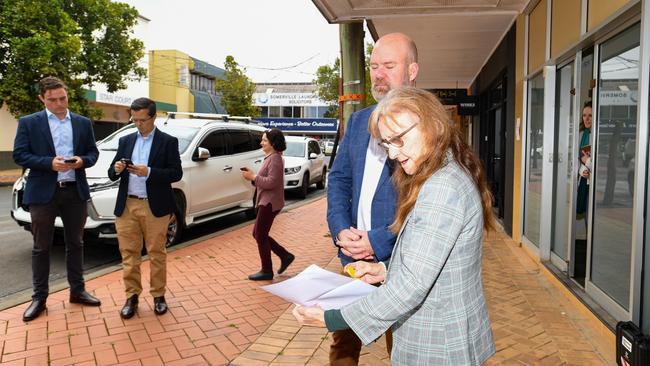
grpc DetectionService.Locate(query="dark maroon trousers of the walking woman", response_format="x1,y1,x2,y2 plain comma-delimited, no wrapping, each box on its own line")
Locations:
253,203,289,273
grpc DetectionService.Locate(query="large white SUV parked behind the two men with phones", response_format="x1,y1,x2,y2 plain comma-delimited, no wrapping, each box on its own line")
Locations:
11,113,265,245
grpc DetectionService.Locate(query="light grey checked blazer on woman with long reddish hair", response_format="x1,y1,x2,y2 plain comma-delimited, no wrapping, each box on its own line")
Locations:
341,155,495,366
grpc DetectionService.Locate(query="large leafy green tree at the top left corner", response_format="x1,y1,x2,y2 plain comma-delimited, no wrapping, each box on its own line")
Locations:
0,0,146,118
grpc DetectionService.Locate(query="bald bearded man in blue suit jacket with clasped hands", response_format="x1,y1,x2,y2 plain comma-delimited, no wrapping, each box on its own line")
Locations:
327,33,418,366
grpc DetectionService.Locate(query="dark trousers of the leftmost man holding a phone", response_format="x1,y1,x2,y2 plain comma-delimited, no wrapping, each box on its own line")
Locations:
29,185,87,300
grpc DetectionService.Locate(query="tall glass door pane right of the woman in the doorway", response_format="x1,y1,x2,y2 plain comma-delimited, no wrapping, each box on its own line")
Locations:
587,24,640,312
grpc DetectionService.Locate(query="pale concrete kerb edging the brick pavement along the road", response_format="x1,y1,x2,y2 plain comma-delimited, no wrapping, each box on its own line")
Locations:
0,195,326,311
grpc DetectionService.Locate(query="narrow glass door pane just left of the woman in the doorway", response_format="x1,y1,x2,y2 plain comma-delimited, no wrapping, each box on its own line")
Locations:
551,62,575,271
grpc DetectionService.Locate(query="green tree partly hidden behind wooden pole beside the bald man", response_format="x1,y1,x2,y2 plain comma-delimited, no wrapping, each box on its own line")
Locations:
313,43,377,118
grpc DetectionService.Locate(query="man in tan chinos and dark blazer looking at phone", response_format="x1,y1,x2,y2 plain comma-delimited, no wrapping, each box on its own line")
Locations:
108,98,183,319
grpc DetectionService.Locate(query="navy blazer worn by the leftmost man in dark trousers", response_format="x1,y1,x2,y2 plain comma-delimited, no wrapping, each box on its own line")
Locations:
13,110,99,204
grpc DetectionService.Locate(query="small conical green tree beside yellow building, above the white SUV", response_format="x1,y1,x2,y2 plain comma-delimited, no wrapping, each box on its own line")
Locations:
214,55,262,117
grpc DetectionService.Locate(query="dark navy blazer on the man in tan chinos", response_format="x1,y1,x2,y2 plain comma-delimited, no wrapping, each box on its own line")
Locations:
108,129,183,217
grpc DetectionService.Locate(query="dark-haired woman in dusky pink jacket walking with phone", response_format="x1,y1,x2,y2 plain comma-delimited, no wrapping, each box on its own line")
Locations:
242,128,295,281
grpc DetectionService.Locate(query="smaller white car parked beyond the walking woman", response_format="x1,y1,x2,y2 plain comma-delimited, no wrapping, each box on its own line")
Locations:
283,136,327,198
